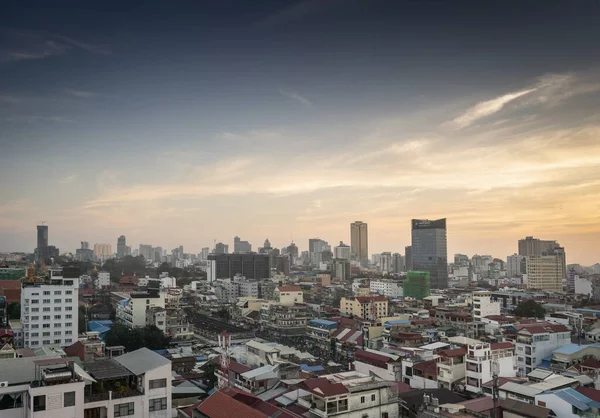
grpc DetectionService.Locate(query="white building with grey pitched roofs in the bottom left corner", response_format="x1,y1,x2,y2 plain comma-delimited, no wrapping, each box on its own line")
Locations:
0,348,172,418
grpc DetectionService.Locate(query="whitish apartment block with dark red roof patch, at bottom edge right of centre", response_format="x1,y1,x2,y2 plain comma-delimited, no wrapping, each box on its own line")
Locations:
298,371,399,418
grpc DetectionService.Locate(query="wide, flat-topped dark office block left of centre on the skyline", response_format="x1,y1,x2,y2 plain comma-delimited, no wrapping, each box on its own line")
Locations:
206,254,271,282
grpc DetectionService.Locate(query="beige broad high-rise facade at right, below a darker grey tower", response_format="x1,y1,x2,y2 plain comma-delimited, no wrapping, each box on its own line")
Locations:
526,255,564,292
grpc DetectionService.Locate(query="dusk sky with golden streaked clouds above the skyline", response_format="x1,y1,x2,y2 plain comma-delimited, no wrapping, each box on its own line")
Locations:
0,0,600,265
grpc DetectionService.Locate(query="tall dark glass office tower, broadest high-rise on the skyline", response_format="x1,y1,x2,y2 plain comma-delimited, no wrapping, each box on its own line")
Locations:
411,218,448,289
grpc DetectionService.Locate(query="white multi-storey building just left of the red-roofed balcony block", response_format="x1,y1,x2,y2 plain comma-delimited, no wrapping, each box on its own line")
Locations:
466,342,517,393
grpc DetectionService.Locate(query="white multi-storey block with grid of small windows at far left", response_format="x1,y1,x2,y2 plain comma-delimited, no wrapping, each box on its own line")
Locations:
21,268,79,348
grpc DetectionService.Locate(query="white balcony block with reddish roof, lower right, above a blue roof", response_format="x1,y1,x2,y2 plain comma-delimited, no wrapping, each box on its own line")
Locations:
516,322,571,376
